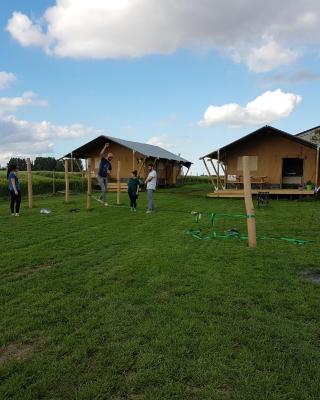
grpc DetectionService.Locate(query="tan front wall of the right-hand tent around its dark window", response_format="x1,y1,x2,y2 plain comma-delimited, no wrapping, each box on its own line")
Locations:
220,134,319,185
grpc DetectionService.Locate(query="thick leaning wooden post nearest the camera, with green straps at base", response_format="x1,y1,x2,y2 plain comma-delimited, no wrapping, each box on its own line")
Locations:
242,156,257,247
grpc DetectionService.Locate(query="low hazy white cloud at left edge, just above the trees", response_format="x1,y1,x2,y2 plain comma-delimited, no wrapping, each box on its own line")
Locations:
0,115,94,163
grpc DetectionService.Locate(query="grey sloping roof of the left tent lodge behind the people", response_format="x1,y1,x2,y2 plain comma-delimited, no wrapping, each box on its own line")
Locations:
63,135,192,166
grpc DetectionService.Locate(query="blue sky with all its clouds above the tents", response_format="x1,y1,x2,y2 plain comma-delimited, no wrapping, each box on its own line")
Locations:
0,0,320,174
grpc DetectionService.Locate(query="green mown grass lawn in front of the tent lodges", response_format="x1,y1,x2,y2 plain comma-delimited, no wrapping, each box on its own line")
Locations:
0,184,320,400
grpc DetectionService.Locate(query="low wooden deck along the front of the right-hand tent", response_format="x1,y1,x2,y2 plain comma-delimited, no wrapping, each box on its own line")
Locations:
207,189,314,198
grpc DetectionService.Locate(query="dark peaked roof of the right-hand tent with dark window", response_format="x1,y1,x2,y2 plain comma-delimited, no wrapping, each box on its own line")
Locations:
200,125,317,159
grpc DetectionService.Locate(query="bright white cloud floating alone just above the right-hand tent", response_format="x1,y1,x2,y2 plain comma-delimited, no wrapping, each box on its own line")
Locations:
200,89,302,127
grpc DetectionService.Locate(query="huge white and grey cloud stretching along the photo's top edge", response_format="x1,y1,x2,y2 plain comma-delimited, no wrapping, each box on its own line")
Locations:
7,0,320,71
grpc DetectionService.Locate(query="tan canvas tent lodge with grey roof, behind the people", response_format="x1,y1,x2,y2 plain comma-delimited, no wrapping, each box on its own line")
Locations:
63,135,192,190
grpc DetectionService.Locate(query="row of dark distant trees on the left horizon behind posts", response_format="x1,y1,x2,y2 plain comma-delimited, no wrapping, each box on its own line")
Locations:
7,157,83,172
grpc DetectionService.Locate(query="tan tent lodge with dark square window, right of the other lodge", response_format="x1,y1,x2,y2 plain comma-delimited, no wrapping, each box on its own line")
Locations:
200,126,319,197
